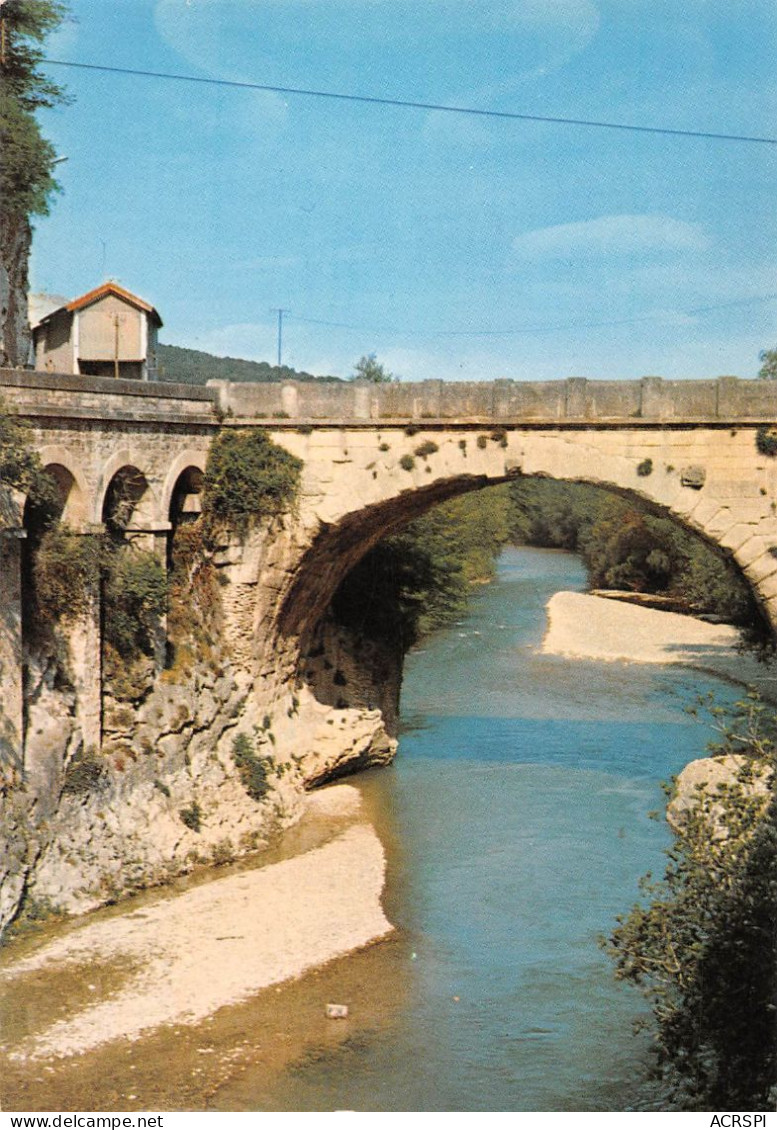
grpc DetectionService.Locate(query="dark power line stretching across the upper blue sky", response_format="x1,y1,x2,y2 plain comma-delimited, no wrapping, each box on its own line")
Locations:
45,59,777,145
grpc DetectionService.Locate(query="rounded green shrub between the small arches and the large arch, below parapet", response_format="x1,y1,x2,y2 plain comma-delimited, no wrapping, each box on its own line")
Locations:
202,428,303,536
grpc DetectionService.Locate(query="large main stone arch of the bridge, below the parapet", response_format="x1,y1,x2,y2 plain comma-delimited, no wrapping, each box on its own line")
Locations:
277,426,777,647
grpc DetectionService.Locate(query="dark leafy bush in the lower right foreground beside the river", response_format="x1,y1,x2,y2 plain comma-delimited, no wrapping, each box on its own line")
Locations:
604,697,777,1111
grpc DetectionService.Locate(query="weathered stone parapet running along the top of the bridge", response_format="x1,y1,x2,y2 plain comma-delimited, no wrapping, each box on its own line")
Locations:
0,370,777,428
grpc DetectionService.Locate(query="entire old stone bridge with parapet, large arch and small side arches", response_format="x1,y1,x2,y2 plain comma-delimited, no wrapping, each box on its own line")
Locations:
0,371,777,763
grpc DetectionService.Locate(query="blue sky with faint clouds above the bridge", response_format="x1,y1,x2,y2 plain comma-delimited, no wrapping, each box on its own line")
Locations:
32,0,777,380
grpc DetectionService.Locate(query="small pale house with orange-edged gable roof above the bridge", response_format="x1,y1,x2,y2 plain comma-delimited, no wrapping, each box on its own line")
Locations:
33,283,161,381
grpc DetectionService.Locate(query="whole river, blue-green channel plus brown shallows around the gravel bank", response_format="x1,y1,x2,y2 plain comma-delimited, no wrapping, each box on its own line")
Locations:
0,549,736,1112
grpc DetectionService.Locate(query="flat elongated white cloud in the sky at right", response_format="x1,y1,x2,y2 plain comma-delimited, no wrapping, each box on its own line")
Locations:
513,215,709,260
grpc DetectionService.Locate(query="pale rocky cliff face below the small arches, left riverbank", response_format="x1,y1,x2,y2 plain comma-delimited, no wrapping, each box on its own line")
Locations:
0,523,401,929
